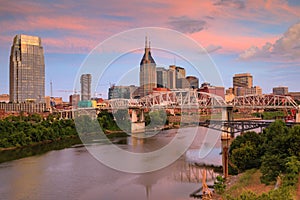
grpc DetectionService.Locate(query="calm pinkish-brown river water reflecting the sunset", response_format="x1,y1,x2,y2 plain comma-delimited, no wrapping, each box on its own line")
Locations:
0,128,221,200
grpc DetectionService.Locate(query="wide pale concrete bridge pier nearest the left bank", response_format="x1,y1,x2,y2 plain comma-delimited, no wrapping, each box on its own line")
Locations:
131,108,145,133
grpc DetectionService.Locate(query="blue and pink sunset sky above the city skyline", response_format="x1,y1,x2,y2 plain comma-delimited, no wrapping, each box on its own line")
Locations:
0,0,300,100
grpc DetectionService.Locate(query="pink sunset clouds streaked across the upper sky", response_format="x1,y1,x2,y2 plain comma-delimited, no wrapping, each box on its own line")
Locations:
0,0,300,55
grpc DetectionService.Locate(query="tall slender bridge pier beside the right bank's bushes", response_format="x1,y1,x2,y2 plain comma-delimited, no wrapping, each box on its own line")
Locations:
221,107,233,179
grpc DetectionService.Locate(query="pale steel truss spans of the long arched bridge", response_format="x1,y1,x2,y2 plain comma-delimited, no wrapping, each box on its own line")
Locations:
109,90,299,110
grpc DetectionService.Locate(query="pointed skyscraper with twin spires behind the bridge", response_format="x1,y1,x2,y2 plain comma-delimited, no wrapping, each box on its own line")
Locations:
140,38,157,97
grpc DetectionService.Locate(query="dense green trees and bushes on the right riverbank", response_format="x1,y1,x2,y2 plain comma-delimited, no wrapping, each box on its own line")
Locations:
227,121,300,200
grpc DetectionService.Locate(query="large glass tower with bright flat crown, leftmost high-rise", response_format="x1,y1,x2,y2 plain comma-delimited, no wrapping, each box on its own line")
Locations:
9,34,45,103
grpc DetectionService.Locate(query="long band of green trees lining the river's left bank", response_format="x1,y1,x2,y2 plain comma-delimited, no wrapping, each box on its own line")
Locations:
0,110,130,149
